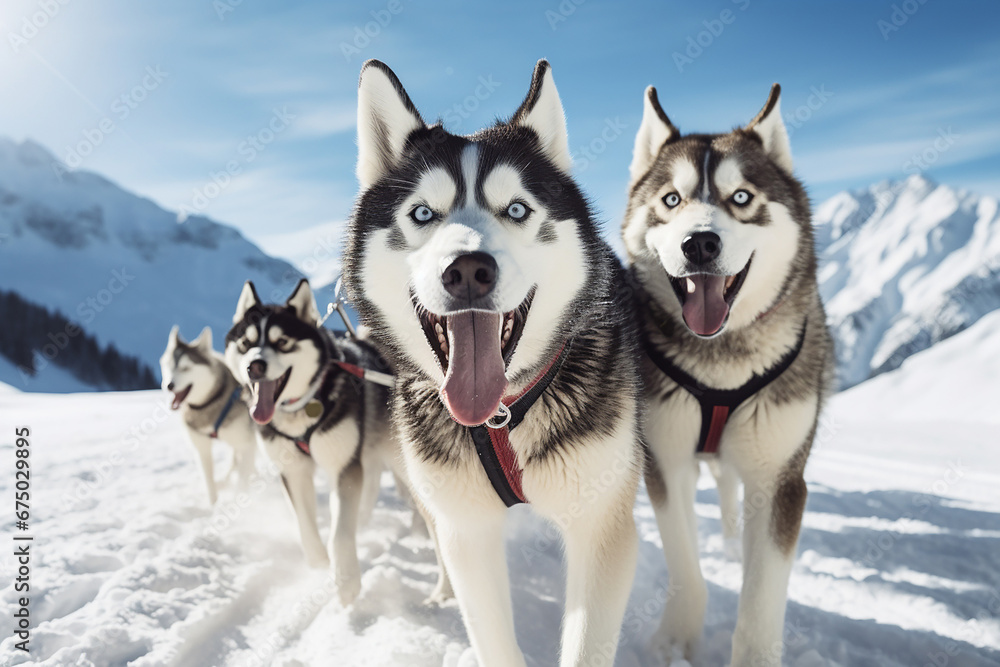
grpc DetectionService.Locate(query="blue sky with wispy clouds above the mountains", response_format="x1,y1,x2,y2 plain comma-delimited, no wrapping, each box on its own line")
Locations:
0,0,1000,245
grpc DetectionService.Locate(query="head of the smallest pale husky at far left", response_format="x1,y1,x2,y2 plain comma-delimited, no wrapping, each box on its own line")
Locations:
160,325,219,410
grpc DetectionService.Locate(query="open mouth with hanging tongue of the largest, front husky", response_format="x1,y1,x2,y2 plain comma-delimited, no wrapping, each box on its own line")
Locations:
414,287,535,426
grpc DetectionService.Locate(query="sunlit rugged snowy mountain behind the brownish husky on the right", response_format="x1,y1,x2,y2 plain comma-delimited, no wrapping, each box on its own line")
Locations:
814,175,1000,388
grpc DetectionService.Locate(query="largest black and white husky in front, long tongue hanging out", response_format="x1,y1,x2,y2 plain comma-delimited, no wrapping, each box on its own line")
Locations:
344,60,643,667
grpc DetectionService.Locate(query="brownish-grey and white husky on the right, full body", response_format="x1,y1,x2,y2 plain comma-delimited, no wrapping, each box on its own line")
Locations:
622,85,832,666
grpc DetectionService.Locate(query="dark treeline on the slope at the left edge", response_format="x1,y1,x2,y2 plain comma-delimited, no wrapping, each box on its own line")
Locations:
0,290,158,391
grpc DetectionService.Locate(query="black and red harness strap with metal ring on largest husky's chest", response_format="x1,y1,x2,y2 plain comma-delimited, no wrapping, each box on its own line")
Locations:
468,340,573,507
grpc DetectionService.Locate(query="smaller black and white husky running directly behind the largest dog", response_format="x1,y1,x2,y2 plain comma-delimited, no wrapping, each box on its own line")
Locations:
226,280,450,605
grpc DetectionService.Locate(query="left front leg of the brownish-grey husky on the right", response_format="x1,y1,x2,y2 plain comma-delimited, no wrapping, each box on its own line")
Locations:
647,458,708,660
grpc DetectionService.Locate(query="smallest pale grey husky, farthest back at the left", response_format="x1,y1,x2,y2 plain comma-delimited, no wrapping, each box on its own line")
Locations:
160,326,257,505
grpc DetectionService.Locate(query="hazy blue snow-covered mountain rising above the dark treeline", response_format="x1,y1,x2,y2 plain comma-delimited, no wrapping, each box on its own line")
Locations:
0,138,301,391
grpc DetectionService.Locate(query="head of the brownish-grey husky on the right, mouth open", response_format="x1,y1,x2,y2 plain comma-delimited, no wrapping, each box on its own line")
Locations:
622,84,814,338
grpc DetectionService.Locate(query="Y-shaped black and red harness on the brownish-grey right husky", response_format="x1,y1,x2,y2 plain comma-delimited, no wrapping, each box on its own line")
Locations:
643,321,809,455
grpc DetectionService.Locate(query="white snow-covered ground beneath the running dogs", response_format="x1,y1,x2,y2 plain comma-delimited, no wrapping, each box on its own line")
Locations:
0,314,1000,667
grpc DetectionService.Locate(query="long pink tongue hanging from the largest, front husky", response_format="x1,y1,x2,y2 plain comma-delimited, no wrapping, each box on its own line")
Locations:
441,310,507,426
